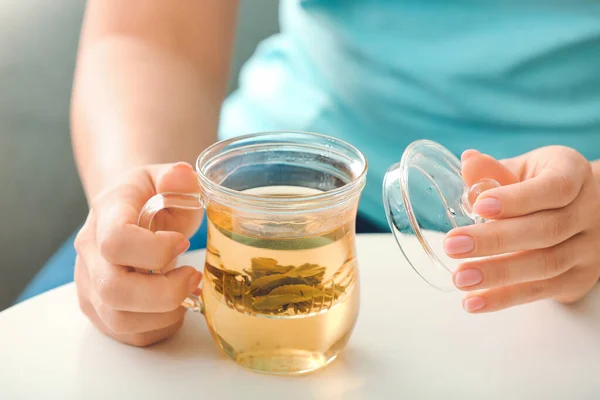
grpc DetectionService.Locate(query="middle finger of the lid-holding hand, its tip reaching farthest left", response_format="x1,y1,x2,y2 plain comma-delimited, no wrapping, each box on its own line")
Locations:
444,198,589,258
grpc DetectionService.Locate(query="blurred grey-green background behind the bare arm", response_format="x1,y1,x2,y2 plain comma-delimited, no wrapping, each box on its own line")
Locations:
0,0,278,311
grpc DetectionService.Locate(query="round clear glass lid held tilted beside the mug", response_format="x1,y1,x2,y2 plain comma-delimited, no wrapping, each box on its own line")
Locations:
383,140,499,291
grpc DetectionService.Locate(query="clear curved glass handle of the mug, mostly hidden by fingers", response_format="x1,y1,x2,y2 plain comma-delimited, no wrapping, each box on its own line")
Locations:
138,193,204,313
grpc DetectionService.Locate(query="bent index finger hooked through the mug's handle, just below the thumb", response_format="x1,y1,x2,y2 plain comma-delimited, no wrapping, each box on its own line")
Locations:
96,199,190,270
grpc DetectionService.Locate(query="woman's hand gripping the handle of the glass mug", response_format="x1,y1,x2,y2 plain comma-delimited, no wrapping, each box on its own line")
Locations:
75,163,202,346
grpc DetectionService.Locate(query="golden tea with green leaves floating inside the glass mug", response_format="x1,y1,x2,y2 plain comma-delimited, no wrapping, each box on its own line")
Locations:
203,186,359,374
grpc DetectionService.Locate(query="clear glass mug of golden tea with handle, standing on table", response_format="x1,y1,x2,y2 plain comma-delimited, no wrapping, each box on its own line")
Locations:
140,132,367,374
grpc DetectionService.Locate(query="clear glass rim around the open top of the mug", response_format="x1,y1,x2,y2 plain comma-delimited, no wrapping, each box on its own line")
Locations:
196,130,368,208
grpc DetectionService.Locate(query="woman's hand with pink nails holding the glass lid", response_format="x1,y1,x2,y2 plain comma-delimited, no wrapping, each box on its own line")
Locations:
444,146,600,313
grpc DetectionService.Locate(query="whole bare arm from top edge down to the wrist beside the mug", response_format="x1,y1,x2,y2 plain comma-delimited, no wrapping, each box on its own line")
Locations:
71,0,236,201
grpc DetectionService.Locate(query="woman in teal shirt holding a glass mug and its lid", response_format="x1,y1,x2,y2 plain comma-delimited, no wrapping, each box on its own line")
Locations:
17,0,600,345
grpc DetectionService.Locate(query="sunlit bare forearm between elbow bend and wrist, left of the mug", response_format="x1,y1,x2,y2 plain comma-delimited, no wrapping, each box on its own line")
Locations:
71,39,221,200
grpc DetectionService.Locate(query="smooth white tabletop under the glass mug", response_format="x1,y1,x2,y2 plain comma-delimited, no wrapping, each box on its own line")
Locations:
0,235,600,400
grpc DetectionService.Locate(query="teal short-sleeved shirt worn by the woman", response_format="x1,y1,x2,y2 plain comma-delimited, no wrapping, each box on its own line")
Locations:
220,0,600,225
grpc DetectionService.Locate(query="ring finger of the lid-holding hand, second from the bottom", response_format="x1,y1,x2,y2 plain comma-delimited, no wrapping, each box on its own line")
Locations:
453,234,592,291
